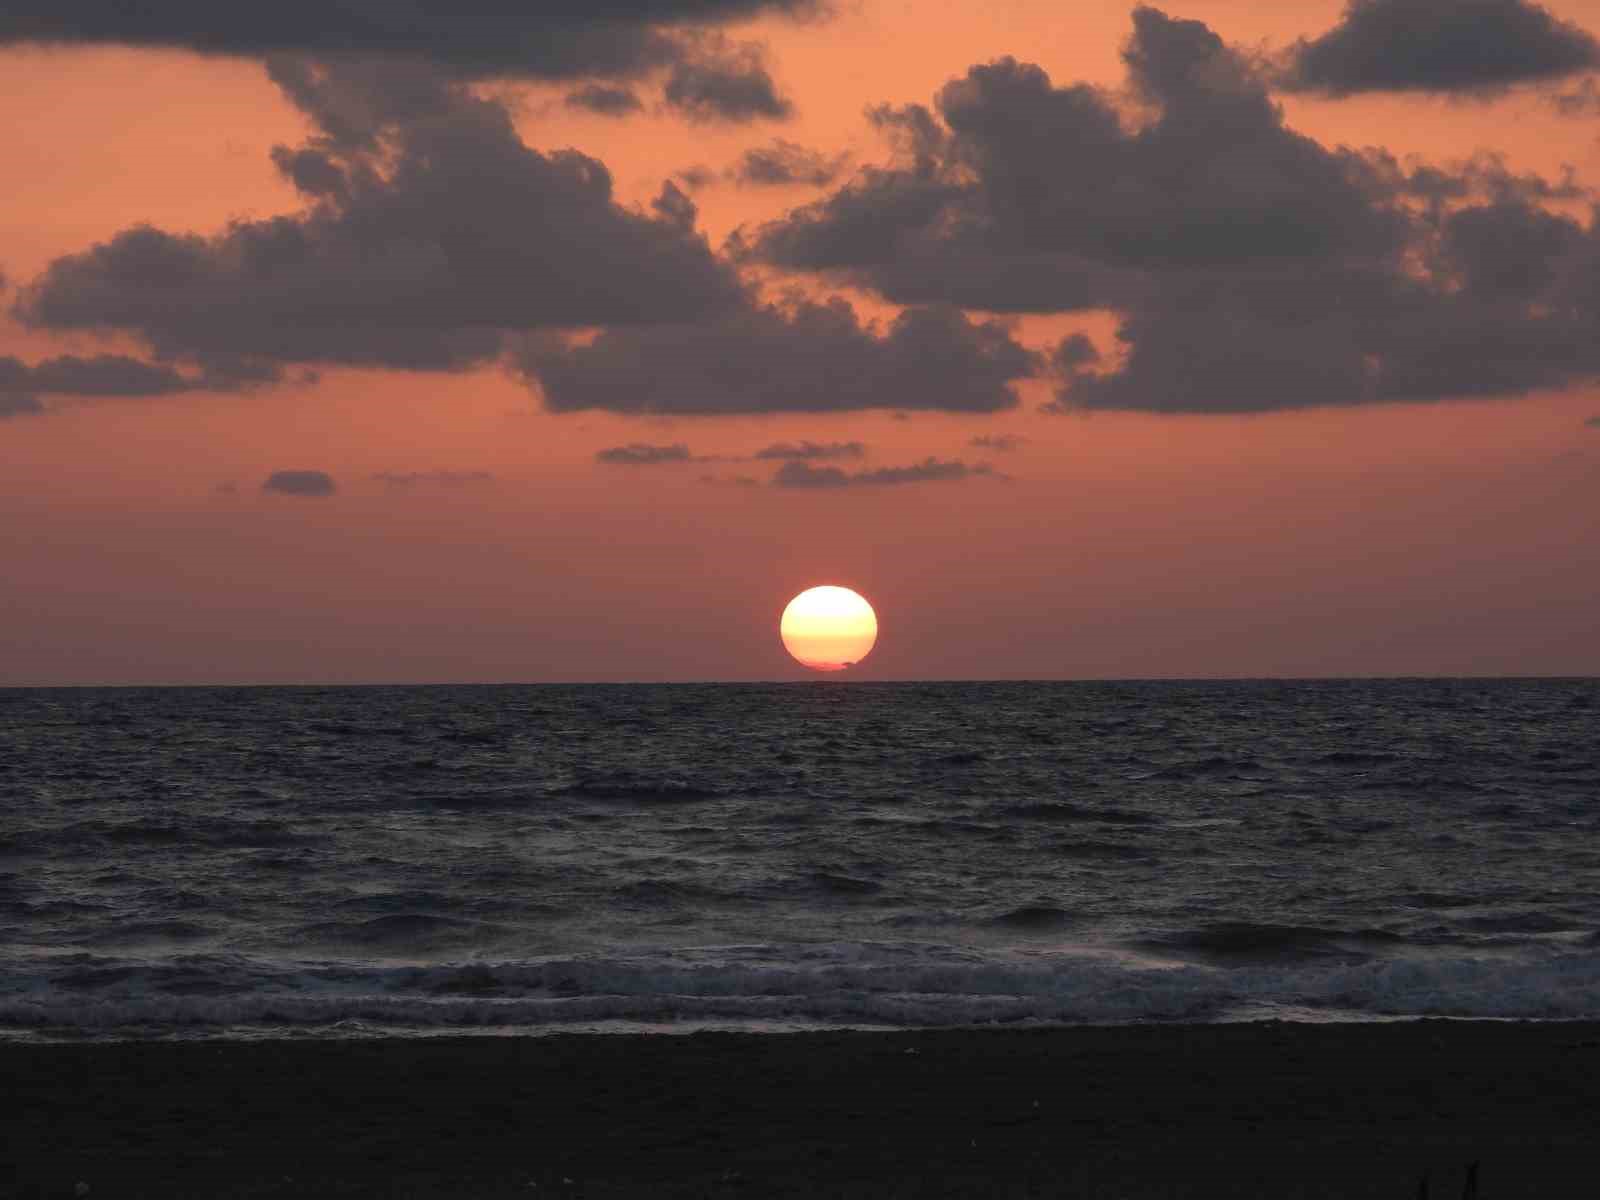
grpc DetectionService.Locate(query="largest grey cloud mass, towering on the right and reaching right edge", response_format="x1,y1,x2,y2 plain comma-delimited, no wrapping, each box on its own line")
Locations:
730,8,1600,413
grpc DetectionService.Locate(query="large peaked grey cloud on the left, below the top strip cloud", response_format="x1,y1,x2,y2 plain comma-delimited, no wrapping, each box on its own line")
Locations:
16,59,742,373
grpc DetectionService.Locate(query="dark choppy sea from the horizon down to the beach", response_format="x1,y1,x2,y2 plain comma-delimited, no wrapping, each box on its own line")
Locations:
0,680,1600,1040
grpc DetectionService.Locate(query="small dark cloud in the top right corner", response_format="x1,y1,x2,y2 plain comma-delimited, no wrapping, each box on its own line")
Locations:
1280,0,1600,96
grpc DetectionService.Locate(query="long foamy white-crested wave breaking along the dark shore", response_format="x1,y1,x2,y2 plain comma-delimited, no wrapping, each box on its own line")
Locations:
9,944,1600,1037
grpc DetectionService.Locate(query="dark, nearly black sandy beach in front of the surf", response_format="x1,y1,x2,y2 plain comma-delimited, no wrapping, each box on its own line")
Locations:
0,1021,1600,1200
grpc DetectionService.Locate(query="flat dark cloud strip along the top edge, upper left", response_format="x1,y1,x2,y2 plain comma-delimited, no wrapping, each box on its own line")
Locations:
0,0,821,78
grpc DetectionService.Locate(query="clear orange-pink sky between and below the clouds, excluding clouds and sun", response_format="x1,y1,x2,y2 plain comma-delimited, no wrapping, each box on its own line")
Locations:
0,0,1600,685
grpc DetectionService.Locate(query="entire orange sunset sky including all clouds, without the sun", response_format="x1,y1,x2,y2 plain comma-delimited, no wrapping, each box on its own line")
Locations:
0,0,1600,685
